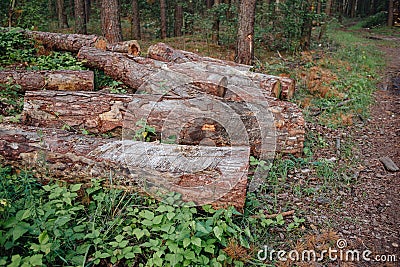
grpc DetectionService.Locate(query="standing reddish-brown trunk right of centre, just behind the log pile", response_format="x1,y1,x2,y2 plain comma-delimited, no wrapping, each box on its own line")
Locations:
235,0,256,65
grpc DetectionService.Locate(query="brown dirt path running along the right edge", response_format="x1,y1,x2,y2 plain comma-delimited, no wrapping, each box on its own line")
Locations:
338,37,400,266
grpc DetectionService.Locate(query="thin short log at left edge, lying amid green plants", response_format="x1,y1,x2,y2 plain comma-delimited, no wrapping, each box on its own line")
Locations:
0,70,94,92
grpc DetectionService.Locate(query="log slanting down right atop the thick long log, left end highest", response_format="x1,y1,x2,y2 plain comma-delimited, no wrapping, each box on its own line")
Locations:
78,47,227,96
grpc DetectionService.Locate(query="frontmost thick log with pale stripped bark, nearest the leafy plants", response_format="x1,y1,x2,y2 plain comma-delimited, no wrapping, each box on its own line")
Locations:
0,124,249,210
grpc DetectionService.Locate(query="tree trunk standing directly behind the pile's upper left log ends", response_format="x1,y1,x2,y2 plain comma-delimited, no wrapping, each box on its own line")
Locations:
101,0,122,43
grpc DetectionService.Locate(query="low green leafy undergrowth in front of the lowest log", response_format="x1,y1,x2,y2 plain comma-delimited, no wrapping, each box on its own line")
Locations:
0,167,253,266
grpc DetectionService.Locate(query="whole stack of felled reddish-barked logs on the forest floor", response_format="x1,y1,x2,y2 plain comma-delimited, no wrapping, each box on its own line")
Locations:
0,31,304,210
